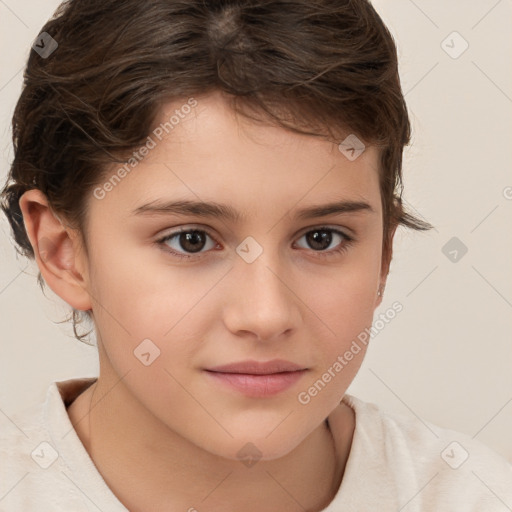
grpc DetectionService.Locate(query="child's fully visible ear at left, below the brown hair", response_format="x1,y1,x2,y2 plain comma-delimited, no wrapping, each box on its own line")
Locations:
19,189,92,311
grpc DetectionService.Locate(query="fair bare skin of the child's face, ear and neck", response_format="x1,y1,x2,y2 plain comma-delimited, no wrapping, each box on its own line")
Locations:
20,90,392,512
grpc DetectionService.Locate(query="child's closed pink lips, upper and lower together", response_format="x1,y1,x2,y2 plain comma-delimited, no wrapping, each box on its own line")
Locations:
205,359,308,398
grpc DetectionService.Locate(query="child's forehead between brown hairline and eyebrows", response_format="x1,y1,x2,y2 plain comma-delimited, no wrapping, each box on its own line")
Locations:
91,94,380,221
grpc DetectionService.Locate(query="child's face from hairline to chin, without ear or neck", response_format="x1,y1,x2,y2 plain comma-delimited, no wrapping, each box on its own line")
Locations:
79,91,385,459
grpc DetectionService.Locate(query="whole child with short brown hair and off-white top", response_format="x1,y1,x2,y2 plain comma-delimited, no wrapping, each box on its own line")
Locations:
0,0,512,512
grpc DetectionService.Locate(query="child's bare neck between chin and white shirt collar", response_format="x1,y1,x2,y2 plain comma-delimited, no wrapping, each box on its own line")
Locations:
68,372,354,512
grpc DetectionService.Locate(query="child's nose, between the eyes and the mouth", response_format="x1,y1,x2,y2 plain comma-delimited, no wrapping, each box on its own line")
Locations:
224,251,301,341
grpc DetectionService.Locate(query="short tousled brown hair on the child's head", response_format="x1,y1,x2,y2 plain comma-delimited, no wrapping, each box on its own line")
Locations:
0,0,432,340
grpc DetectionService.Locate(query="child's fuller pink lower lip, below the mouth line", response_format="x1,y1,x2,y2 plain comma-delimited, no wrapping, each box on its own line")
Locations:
206,370,307,398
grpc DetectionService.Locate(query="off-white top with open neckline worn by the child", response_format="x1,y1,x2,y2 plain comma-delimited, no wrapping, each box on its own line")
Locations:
0,378,512,512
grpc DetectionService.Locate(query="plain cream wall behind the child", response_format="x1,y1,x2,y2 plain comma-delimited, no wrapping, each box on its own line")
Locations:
0,0,512,462
